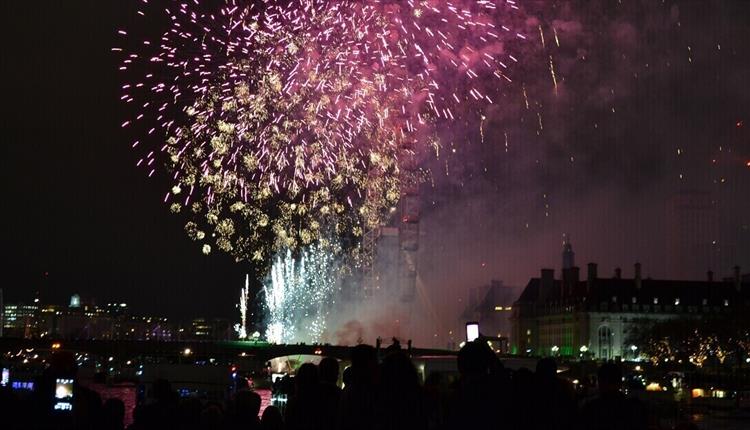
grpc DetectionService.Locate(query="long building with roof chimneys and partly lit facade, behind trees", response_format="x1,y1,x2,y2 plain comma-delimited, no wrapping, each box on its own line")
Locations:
511,242,750,360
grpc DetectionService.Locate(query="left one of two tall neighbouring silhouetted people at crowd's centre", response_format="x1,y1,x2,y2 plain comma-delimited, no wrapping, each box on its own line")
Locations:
338,345,378,430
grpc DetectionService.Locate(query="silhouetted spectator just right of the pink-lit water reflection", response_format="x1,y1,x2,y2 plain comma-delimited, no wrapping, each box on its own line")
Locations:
284,363,321,430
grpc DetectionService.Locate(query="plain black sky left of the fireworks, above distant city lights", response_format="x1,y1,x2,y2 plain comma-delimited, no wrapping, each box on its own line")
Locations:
0,1,244,316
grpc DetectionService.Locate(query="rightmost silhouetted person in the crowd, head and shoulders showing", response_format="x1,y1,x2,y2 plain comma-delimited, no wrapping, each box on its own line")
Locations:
581,363,648,430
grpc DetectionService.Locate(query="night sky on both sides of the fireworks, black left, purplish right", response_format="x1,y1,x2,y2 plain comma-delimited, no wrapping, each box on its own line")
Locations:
0,0,750,332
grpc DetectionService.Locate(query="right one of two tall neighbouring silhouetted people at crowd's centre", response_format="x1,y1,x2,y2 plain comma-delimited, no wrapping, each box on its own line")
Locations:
376,350,427,430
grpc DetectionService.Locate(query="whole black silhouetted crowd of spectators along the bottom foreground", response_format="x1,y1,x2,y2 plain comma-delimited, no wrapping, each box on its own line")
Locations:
0,342,692,430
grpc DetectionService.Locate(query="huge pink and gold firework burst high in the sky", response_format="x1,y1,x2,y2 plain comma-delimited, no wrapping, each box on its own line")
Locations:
115,0,524,266
